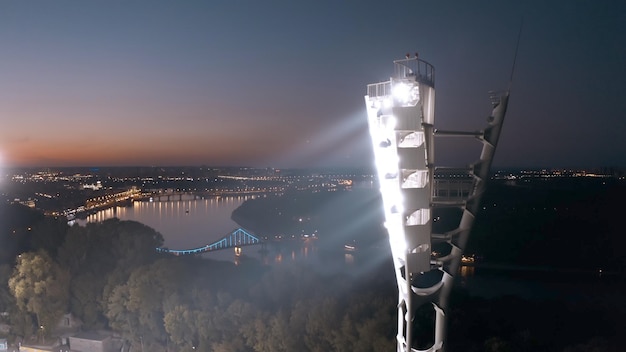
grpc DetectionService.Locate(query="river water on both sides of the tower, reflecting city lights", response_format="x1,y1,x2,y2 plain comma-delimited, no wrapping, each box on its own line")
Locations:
75,196,626,302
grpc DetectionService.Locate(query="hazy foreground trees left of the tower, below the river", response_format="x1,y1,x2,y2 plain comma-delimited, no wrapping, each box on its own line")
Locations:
0,205,396,352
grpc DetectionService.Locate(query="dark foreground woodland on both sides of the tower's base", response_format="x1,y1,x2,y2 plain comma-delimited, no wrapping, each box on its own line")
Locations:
0,202,626,352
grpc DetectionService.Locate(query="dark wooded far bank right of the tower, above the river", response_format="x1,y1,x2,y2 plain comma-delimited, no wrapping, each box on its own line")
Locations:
468,178,626,275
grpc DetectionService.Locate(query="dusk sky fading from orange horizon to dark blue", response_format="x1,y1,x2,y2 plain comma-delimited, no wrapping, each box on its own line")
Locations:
0,0,626,168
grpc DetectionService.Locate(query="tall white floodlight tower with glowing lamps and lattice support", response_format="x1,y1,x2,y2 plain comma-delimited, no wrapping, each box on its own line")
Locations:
365,54,509,352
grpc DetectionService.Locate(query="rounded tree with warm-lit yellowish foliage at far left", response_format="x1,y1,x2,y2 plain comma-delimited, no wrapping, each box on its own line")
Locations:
9,250,70,334
